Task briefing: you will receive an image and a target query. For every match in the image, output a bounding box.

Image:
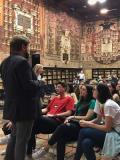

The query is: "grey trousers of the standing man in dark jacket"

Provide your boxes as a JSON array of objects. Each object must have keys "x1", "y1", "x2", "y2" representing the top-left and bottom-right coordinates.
[{"x1": 5, "y1": 120, "x2": 33, "y2": 160}]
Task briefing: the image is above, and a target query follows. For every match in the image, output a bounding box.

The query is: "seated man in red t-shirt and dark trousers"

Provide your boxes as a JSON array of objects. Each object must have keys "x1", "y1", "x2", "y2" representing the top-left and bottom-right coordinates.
[{"x1": 27, "y1": 82, "x2": 74, "y2": 158}]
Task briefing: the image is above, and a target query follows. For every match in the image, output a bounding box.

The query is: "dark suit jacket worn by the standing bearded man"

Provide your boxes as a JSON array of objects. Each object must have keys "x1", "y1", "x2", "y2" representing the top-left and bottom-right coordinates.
[{"x1": 0, "y1": 55, "x2": 41, "y2": 122}]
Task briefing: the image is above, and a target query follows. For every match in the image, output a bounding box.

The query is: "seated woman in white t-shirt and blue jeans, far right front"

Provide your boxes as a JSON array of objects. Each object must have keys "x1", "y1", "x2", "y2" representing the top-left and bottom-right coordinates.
[{"x1": 74, "y1": 84, "x2": 120, "y2": 160}]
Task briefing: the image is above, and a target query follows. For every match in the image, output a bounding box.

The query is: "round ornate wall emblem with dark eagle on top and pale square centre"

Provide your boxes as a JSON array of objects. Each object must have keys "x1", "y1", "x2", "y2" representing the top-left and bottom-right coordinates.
[{"x1": 92, "y1": 22, "x2": 120, "y2": 64}]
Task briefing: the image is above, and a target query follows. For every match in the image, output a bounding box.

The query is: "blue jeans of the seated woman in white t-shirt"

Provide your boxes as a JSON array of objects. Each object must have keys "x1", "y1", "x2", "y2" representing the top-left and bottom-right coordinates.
[{"x1": 74, "y1": 128, "x2": 106, "y2": 160}]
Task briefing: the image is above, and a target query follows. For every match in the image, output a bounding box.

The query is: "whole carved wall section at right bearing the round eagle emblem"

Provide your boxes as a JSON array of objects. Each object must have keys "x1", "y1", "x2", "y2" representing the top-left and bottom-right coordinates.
[{"x1": 81, "y1": 19, "x2": 120, "y2": 64}]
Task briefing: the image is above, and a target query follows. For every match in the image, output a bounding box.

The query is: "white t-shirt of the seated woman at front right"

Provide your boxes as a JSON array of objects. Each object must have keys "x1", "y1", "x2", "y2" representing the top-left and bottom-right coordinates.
[{"x1": 94, "y1": 99, "x2": 120, "y2": 127}]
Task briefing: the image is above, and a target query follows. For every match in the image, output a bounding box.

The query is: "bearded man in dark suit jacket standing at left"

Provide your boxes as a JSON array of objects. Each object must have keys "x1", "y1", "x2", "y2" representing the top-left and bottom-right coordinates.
[{"x1": 0, "y1": 36, "x2": 42, "y2": 160}]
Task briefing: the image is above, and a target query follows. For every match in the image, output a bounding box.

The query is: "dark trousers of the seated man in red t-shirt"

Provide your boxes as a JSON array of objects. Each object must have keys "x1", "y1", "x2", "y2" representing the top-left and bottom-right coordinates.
[{"x1": 27, "y1": 116, "x2": 61, "y2": 155}]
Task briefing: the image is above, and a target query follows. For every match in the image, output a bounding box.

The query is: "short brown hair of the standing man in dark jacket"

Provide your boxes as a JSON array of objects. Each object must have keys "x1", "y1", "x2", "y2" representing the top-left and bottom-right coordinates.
[{"x1": 10, "y1": 36, "x2": 29, "y2": 54}]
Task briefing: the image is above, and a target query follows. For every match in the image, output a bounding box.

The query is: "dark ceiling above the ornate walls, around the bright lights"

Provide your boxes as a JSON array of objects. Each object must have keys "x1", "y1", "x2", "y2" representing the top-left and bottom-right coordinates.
[{"x1": 45, "y1": 0, "x2": 120, "y2": 20}]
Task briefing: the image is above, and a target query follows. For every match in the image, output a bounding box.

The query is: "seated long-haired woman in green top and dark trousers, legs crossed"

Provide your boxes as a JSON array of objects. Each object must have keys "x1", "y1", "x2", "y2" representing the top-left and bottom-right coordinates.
[{"x1": 45, "y1": 85, "x2": 95, "y2": 160}]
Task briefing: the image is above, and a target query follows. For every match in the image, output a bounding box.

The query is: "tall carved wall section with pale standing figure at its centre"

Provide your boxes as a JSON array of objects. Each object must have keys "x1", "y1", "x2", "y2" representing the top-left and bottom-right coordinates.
[{"x1": 46, "y1": 8, "x2": 81, "y2": 61}]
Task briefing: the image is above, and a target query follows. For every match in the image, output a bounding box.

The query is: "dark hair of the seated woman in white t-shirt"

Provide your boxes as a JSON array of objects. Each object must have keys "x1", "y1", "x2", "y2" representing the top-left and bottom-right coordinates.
[{"x1": 97, "y1": 84, "x2": 112, "y2": 104}]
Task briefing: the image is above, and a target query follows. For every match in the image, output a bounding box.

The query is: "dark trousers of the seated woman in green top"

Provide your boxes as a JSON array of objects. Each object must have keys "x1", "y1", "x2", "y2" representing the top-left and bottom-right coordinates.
[{"x1": 48, "y1": 123, "x2": 80, "y2": 160}]
